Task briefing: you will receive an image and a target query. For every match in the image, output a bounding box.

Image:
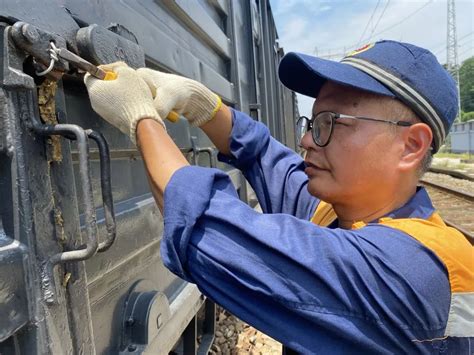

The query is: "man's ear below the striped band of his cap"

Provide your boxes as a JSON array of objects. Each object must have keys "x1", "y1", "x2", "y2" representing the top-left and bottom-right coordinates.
[{"x1": 399, "y1": 123, "x2": 433, "y2": 171}]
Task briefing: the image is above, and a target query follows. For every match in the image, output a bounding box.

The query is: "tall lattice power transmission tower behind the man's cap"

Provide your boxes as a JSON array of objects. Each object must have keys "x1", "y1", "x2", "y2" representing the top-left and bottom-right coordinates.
[{"x1": 446, "y1": 0, "x2": 461, "y2": 121}]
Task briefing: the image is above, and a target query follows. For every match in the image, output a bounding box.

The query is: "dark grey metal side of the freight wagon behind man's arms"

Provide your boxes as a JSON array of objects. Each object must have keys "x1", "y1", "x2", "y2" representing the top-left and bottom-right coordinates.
[{"x1": 0, "y1": 0, "x2": 297, "y2": 354}]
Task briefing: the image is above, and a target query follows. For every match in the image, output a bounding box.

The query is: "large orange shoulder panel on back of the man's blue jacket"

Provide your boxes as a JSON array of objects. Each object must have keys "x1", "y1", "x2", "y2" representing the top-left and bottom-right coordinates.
[{"x1": 379, "y1": 213, "x2": 474, "y2": 293}]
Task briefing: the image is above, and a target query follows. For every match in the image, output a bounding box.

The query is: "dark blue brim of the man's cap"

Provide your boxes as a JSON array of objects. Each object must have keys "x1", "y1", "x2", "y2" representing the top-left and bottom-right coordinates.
[{"x1": 278, "y1": 52, "x2": 395, "y2": 97}]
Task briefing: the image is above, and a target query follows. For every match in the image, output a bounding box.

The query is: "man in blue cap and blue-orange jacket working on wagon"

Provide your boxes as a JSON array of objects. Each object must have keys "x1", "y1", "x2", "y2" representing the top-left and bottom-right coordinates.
[{"x1": 85, "y1": 41, "x2": 474, "y2": 354}]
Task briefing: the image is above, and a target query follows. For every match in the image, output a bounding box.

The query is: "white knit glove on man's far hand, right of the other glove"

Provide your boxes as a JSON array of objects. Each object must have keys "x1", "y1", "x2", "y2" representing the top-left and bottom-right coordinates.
[{"x1": 137, "y1": 68, "x2": 222, "y2": 127}]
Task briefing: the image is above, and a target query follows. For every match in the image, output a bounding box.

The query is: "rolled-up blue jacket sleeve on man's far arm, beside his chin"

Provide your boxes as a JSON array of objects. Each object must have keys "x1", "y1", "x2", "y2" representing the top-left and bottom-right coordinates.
[{"x1": 219, "y1": 110, "x2": 319, "y2": 219}]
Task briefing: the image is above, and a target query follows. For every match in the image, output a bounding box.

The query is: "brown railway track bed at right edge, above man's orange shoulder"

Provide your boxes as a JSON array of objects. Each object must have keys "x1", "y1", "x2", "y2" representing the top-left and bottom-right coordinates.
[{"x1": 420, "y1": 179, "x2": 474, "y2": 244}]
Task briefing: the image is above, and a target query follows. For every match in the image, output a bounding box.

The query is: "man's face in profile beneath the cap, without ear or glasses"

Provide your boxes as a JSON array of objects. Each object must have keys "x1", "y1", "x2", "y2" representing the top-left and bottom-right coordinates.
[{"x1": 301, "y1": 82, "x2": 403, "y2": 204}]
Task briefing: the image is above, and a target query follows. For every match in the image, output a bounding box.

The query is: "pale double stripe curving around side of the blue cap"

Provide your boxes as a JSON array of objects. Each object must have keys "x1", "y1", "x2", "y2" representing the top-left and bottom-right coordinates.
[{"x1": 341, "y1": 57, "x2": 446, "y2": 150}]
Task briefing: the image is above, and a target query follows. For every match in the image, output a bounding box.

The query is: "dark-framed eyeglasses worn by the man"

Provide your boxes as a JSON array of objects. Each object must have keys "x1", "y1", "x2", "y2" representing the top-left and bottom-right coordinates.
[{"x1": 296, "y1": 111, "x2": 413, "y2": 147}]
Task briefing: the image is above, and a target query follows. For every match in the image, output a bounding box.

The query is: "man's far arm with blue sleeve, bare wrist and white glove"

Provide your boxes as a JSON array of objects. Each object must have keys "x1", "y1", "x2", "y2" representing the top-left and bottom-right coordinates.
[{"x1": 137, "y1": 68, "x2": 318, "y2": 219}]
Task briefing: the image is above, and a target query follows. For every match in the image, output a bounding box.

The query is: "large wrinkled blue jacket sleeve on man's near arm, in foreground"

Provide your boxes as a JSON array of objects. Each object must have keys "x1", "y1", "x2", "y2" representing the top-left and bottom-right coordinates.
[{"x1": 161, "y1": 166, "x2": 450, "y2": 353}]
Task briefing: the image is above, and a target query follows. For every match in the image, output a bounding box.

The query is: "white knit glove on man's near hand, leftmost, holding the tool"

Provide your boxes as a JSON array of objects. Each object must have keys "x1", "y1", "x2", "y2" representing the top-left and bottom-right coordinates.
[{"x1": 84, "y1": 62, "x2": 166, "y2": 144}]
